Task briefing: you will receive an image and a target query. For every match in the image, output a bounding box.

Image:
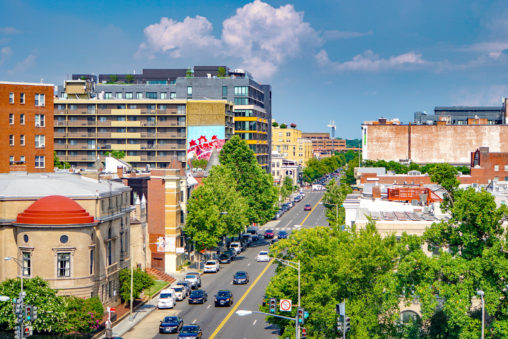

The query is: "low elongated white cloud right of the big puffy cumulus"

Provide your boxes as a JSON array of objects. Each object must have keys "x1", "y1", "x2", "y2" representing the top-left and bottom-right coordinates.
[{"x1": 315, "y1": 50, "x2": 427, "y2": 72}]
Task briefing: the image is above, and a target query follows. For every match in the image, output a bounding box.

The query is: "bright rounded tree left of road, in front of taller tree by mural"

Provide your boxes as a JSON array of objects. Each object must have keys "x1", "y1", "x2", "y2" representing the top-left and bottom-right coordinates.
[{"x1": 185, "y1": 165, "x2": 248, "y2": 249}]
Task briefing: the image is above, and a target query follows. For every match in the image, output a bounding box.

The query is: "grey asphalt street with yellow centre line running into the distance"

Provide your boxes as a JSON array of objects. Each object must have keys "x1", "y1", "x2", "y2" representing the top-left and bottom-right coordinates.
[{"x1": 123, "y1": 192, "x2": 328, "y2": 339}]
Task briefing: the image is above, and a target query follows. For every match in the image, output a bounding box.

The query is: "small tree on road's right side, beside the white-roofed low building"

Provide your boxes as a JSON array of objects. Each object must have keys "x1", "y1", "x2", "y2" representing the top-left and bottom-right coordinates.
[{"x1": 323, "y1": 179, "x2": 352, "y2": 226}]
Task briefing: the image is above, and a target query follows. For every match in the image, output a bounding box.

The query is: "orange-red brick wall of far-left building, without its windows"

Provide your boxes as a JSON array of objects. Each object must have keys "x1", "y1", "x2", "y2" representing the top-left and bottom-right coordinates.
[{"x1": 0, "y1": 83, "x2": 54, "y2": 173}]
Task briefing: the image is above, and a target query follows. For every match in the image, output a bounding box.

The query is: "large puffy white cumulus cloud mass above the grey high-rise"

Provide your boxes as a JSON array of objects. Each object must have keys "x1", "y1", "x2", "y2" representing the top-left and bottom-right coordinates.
[{"x1": 137, "y1": 0, "x2": 321, "y2": 78}]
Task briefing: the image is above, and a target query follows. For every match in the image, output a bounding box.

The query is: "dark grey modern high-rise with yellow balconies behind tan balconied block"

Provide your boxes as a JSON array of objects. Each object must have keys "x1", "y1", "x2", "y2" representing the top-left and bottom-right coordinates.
[{"x1": 67, "y1": 66, "x2": 272, "y2": 171}]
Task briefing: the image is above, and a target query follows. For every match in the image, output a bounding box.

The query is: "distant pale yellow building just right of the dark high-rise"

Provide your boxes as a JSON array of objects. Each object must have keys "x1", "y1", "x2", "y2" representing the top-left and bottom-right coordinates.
[{"x1": 272, "y1": 126, "x2": 313, "y2": 167}]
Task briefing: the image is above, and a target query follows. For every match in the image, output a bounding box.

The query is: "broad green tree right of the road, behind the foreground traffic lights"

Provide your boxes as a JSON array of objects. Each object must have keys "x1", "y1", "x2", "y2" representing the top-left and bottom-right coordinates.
[{"x1": 266, "y1": 223, "x2": 404, "y2": 338}]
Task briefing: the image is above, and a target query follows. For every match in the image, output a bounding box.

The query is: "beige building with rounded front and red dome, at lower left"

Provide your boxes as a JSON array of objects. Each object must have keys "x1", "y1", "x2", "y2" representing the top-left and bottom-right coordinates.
[{"x1": 0, "y1": 173, "x2": 134, "y2": 305}]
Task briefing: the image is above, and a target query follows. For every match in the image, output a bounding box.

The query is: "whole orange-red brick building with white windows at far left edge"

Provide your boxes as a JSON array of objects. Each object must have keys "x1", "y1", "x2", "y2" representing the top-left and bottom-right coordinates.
[{"x1": 0, "y1": 82, "x2": 54, "y2": 173}]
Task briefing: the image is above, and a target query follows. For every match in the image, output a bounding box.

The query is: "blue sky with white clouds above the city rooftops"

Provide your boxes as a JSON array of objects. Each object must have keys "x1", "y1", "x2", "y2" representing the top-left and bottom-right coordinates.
[{"x1": 0, "y1": 0, "x2": 508, "y2": 138}]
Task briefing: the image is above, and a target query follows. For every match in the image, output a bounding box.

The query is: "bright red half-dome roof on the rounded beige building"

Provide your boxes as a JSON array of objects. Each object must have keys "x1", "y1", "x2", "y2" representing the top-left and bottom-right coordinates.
[{"x1": 16, "y1": 195, "x2": 94, "y2": 225}]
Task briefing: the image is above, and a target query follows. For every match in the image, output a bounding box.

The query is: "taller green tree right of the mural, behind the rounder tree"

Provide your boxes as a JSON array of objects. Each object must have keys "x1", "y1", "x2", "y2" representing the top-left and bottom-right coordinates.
[{"x1": 219, "y1": 135, "x2": 278, "y2": 224}]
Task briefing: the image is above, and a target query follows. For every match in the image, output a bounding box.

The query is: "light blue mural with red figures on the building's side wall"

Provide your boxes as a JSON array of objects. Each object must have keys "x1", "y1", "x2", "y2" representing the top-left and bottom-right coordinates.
[{"x1": 187, "y1": 126, "x2": 226, "y2": 160}]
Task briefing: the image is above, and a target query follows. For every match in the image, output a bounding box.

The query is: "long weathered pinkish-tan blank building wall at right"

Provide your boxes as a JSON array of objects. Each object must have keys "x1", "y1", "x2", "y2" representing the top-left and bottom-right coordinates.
[{"x1": 362, "y1": 125, "x2": 508, "y2": 165}]
